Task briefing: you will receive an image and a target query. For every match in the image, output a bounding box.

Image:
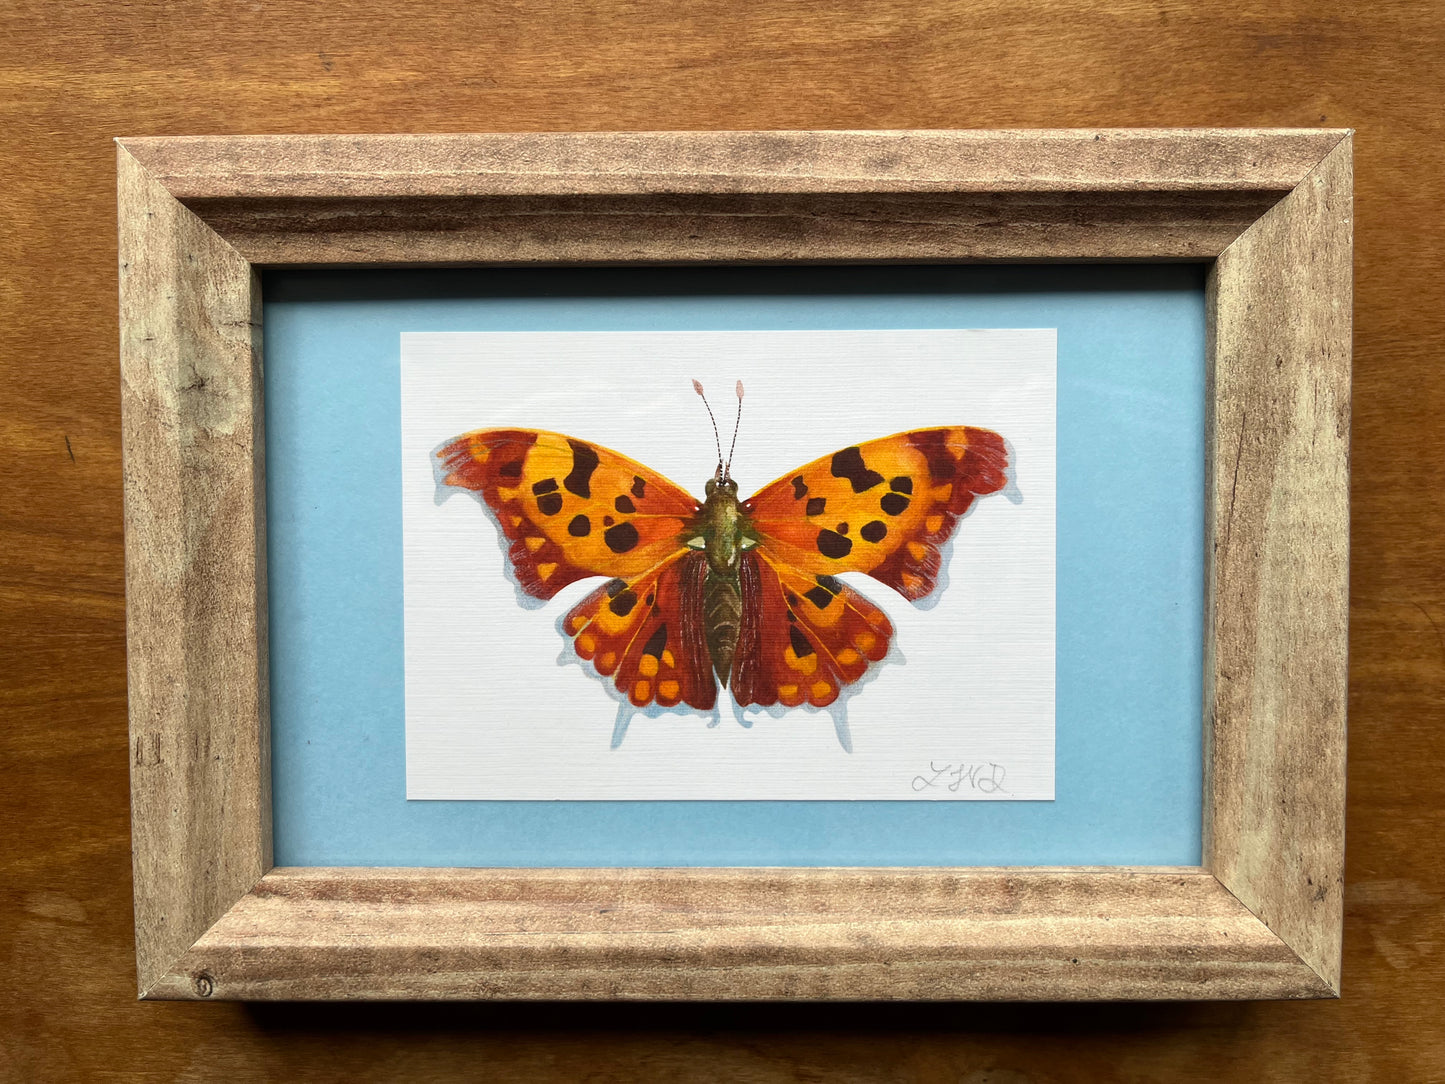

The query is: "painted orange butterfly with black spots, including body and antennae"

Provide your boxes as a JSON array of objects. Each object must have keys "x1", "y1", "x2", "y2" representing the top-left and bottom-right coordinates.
[{"x1": 435, "y1": 382, "x2": 1009, "y2": 725}]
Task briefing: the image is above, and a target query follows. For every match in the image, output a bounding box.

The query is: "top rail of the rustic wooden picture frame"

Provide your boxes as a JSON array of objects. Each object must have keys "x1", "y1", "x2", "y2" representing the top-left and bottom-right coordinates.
[{"x1": 120, "y1": 129, "x2": 1341, "y2": 267}]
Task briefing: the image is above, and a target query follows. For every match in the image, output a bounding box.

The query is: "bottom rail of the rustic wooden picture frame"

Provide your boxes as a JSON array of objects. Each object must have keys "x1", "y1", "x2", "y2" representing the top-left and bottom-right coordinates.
[{"x1": 147, "y1": 867, "x2": 1329, "y2": 1002}]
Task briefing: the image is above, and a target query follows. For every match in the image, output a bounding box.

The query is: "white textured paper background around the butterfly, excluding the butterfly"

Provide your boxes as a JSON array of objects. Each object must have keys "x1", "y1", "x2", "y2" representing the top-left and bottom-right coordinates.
[{"x1": 402, "y1": 330, "x2": 1055, "y2": 801}]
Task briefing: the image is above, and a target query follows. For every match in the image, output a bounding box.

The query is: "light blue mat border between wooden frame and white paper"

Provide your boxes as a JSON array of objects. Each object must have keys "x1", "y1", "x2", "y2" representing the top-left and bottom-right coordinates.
[{"x1": 264, "y1": 266, "x2": 1205, "y2": 866}]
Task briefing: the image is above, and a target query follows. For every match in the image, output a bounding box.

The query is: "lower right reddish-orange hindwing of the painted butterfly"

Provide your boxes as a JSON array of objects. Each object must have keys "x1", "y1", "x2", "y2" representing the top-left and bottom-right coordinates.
[{"x1": 728, "y1": 548, "x2": 893, "y2": 708}]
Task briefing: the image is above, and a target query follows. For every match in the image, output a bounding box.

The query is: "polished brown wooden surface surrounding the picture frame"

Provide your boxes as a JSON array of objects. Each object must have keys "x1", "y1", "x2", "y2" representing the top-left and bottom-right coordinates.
[{"x1": 0, "y1": 0, "x2": 1445, "y2": 1084}]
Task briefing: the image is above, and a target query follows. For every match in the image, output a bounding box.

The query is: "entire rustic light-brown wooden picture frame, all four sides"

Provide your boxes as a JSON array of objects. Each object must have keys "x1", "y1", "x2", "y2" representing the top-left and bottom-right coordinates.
[{"x1": 118, "y1": 130, "x2": 1351, "y2": 1000}]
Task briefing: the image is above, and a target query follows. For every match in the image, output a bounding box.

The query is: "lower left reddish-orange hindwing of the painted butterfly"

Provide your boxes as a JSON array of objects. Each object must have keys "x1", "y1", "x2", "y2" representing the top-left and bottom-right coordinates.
[{"x1": 562, "y1": 551, "x2": 717, "y2": 711}]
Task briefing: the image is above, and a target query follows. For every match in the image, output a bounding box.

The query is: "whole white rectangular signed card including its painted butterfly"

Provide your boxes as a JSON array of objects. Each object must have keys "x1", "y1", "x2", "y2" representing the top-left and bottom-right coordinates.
[{"x1": 402, "y1": 330, "x2": 1056, "y2": 801}]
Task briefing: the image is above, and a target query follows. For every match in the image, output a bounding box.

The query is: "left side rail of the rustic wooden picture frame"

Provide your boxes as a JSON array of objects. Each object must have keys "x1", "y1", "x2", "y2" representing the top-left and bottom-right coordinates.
[{"x1": 117, "y1": 150, "x2": 272, "y2": 986}]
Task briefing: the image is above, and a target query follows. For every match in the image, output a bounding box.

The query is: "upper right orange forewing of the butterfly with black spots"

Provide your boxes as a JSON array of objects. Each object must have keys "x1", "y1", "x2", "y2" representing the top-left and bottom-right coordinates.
[{"x1": 743, "y1": 426, "x2": 1009, "y2": 600}]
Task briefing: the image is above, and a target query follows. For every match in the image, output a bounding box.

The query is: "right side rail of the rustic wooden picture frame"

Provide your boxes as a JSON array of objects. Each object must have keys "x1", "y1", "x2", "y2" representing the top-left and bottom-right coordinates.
[{"x1": 1204, "y1": 139, "x2": 1353, "y2": 989}]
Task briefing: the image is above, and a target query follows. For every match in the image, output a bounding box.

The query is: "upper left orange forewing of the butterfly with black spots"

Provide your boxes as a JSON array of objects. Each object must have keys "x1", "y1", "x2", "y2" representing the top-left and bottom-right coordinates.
[{"x1": 435, "y1": 429, "x2": 699, "y2": 598}]
